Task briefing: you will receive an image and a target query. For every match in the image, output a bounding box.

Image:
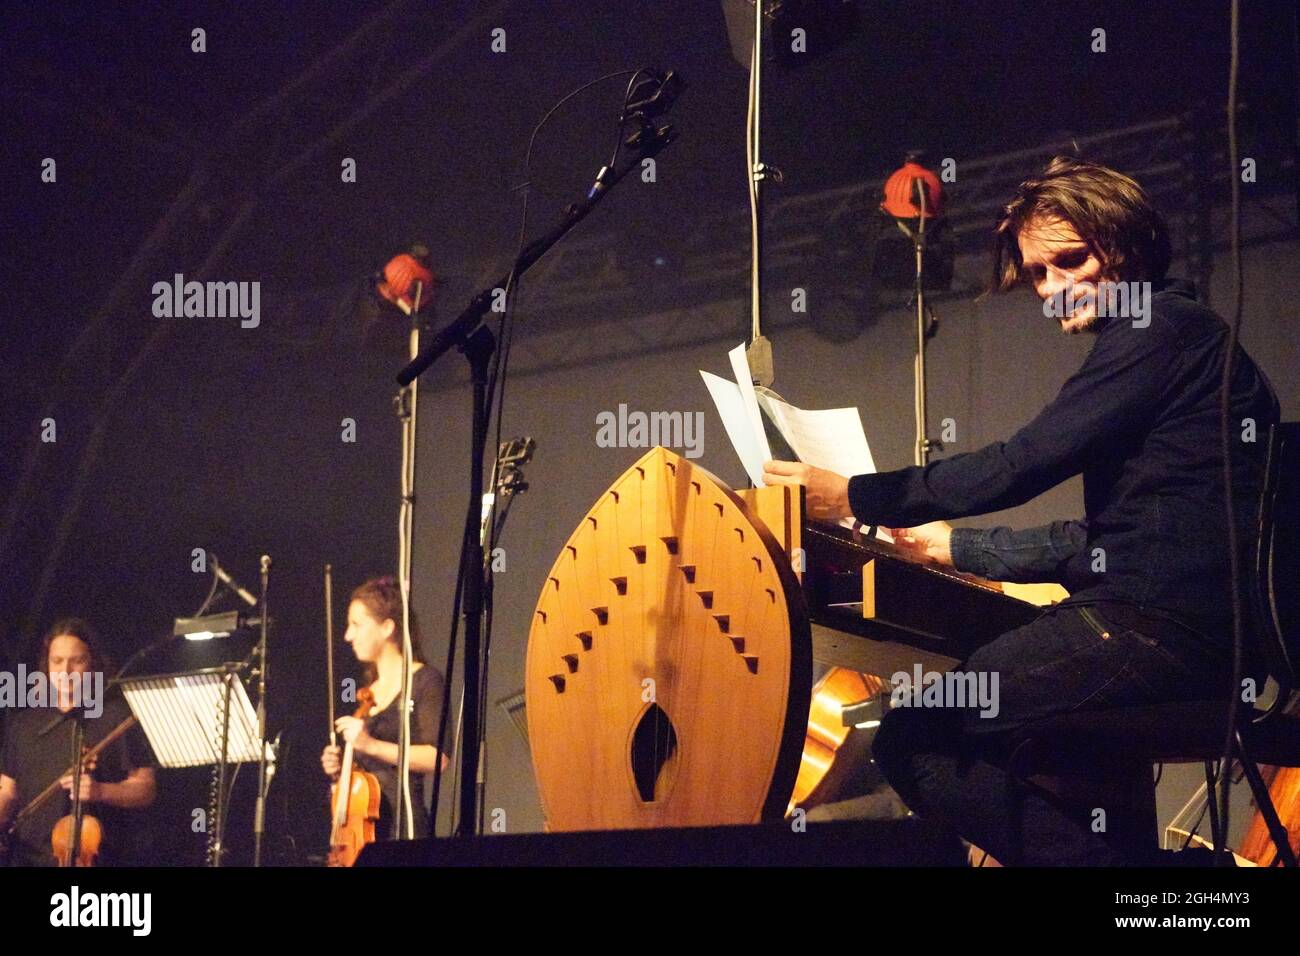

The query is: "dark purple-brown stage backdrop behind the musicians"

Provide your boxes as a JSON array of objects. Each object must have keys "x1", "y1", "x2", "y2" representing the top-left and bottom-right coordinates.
[{"x1": 0, "y1": 0, "x2": 1300, "y2": 864}]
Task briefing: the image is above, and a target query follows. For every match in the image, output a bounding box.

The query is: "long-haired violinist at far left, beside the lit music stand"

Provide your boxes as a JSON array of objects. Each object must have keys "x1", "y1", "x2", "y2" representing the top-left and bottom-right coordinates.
[{"x1": 0, "y1": 618, "x2": 157, "y2": 866}]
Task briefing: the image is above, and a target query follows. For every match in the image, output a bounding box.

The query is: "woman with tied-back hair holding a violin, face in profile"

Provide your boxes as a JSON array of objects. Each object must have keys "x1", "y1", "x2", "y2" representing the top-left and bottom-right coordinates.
[{"x1": 321, "y1": 578, "x2": 447, "y2": 839}]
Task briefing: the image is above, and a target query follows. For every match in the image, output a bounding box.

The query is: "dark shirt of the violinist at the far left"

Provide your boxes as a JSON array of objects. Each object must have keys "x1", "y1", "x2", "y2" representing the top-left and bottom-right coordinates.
[{"x1": 0, "y1": 697, "x2": 153, "y2": 866}]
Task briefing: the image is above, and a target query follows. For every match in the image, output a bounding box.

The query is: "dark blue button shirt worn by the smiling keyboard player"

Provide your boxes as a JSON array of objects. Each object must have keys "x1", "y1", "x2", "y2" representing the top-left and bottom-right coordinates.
[{"x1": 849, "y1": 280, "x2": 1279, "y2": 648}]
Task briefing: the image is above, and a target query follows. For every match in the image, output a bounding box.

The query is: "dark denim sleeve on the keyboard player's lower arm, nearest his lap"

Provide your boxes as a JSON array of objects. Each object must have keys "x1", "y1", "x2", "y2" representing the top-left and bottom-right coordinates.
[{"x1": 949, "y1": 522, "x2": 1088, "y2": 584}]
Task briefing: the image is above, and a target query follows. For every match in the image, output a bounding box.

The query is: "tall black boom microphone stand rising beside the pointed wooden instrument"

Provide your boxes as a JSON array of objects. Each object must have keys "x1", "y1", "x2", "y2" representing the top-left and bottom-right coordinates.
[{"x1": 397, "y1": 121, "x2": 676, "y2": 836}]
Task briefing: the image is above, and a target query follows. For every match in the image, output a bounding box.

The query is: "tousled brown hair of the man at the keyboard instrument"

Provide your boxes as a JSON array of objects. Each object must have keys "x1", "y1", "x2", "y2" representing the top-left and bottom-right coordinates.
[{"x1": 992, "y1": 156, "x2": 1170, "y2": 293}]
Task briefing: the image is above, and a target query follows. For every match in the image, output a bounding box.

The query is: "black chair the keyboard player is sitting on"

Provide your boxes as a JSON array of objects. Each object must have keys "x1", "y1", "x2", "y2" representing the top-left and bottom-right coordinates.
[{"x1": 1010, "y1": 421, "x2": 1300, "y2": 866}]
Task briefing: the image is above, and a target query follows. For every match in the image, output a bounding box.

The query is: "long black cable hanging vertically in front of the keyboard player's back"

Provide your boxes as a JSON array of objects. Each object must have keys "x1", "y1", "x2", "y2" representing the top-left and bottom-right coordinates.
[{"x1": 1212, "y1": 0, "x2": 1245, "y2": 865}]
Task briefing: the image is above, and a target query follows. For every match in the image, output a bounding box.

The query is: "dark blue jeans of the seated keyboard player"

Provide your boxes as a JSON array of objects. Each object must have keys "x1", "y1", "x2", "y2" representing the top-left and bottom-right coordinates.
[{"x1": 872, "y1": 606, "x2": 1231, "y2": 866}]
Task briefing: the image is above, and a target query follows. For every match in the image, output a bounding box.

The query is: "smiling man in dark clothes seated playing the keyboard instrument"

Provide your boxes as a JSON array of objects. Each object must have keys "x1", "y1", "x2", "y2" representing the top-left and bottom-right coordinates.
[{"x1": 766, "y1": 157, "x2": 1278, "y2": 865}]
